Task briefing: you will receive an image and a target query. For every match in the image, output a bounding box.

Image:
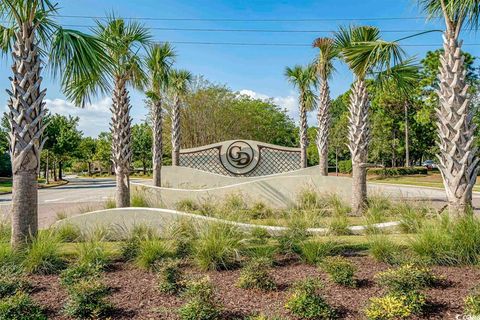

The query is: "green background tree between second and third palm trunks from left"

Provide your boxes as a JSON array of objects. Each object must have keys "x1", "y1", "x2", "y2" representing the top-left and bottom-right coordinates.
[{"x1": 132, "y1": 123, "x2": 153, "y2": 175}]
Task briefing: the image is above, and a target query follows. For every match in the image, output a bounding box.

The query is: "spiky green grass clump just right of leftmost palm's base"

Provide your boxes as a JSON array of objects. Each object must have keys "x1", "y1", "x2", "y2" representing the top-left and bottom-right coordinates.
[{"x1": 23, "y1": 231, "x2": 66, "y2": 274}]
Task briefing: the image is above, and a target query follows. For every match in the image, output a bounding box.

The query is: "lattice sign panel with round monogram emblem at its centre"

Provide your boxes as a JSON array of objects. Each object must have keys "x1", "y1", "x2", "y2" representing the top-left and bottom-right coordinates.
[{"x1": 179, "y1": 140, "x2": 301, "y2": 177}]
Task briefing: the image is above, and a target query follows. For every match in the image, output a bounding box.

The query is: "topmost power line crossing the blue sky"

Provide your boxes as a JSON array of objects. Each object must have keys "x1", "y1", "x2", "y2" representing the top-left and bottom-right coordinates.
[{"x1": 57, "y1": 15, "x2": 426, "y2": 22}]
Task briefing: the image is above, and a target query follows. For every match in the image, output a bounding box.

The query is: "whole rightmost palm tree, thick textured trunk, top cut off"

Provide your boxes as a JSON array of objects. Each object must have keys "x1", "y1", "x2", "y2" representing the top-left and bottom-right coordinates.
[{"x1": 420, "y1": 0, "x2": 480, "y2": 215}]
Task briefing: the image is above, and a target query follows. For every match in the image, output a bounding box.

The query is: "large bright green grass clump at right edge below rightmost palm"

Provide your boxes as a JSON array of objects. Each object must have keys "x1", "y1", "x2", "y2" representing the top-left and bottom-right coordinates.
[{"x1": 411, "y1": 214, "x2": 480, "y2": 265}]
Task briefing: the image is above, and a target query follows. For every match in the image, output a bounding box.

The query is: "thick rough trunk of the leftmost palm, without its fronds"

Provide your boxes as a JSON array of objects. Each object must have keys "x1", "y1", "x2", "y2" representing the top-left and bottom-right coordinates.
[{"x1": 7, "y1": 24, "x2": 46, "y2": 248}]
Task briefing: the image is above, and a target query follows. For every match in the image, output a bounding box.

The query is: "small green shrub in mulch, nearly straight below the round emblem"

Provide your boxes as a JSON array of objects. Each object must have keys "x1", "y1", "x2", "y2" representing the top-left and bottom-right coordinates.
[{"x1": 237, "y1": 259, "x2": 277, "y2": 291}]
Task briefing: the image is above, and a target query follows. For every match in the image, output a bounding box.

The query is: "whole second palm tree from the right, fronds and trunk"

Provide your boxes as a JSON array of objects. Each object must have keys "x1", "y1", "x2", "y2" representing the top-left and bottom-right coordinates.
[{"x1": 335, "y1": 26, "x2": 412, "y2": 215}]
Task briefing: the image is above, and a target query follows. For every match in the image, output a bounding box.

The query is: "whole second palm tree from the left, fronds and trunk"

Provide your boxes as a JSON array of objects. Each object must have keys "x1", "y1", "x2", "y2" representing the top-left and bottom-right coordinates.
[{"x1": 96, "y1": 17, "x2": 151, "y2": 208}]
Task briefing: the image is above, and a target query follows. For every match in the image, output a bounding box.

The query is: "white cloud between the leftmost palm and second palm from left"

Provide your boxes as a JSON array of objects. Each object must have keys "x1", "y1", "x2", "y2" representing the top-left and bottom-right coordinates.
[{"x1": 45, "y1": 98, "x2": 112, "y2": 137}]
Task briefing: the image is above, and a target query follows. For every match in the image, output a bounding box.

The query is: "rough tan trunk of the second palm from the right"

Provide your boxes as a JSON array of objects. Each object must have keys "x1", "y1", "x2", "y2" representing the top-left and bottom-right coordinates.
[{"x1": 348, "y1": 79, "x2": 369, "y2": 215}]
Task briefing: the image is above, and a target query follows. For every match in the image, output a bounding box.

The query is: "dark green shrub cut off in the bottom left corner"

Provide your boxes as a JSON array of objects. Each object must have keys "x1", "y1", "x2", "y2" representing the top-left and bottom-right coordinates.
[{"x1": 0, "y1": 292, "x2": 47, "y2": 320}]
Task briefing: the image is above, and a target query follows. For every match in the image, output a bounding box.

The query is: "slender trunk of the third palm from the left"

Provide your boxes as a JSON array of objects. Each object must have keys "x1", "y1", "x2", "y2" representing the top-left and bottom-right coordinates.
[{"x1": 153, "y1": 101, "x2": 163, "y2": 187}]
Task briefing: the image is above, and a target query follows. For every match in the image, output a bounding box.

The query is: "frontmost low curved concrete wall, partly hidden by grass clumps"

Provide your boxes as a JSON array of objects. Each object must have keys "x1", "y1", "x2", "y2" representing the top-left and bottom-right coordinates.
[{"x1": 54, "y1": 208, "x2": 399, "y2": 235}]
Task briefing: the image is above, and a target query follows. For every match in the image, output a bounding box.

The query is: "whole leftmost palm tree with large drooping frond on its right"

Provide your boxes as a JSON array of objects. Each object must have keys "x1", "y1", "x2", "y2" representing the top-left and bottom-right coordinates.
[{"x1": 0, "y1": 0, "x2": 110, "y2": 248}]
